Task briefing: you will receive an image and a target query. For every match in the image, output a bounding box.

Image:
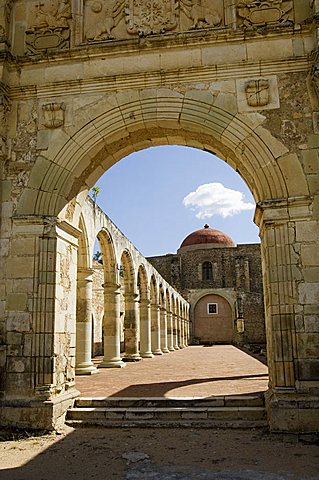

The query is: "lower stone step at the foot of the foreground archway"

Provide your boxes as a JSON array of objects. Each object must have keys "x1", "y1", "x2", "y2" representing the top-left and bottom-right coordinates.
[{"x1": 66, "y1": 406, "x2": 267, "y2": 428}]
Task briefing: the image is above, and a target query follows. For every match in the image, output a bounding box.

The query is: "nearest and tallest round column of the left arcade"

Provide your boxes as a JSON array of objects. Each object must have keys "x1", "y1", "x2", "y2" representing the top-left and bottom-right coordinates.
[{"x1": 75, "y1": 268, "x2": 97, "y2": 375}]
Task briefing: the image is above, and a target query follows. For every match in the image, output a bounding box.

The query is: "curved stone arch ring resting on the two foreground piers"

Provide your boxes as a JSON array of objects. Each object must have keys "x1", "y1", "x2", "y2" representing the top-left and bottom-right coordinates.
[{"x1": 18, "y1": 90, "x2": 308, "y2": 214}]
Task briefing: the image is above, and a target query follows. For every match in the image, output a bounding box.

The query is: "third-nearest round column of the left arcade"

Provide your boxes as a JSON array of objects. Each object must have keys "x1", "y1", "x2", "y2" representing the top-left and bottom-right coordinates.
[{"x1": 123, "y1": 293, "x2": 142, "y2": 362}]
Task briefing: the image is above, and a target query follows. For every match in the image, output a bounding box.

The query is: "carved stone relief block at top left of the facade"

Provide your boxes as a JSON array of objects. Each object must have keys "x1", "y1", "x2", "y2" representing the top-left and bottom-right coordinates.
[{"x1": 26, "y1": 0, "x2": 72, "y2": 53}]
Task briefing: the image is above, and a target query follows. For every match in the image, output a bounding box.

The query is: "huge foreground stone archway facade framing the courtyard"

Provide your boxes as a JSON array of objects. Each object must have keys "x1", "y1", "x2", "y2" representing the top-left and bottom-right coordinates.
[{"x1": 1, "y1": 6, "x2": 319, "y2": 431}]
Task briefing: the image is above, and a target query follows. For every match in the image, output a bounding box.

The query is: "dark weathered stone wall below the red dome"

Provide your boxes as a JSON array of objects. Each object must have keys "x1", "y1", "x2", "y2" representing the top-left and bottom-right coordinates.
[{"x1": 148, "y1": 244, "x2": 266, "y2": 343}]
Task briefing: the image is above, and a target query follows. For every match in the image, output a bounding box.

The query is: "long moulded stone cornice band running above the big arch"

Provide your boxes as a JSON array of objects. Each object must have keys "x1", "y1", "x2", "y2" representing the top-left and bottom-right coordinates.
[{"x1": 8, "y1": 56, "x2": 313, "y2": 100}]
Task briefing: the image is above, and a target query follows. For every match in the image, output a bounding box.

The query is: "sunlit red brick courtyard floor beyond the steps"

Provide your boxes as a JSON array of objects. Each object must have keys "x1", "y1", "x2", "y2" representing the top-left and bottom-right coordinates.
[{"x1": 76, "y1": 345, "x2": 268, "y2": 397}]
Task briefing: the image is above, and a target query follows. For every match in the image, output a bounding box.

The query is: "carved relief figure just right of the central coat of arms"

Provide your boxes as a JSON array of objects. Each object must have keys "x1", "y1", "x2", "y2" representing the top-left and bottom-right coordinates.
[{"x1": 181, "y1": 0, "x2": 222, "y2": 29}]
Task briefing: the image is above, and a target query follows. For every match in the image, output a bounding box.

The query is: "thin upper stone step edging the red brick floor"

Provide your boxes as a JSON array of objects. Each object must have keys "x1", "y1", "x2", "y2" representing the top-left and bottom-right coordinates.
[{"x1": 75, "y1": 394, "x2": 265, "y2": 408}]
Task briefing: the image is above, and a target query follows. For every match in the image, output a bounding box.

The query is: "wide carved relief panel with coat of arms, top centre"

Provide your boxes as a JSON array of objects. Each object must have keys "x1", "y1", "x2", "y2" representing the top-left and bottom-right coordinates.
[{"x1": 84, "y1": 0, "x2": 225, "y2": 42}]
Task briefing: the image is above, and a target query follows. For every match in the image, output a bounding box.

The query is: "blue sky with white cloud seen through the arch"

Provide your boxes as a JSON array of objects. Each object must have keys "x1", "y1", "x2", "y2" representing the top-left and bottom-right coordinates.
[{"x1": 92, "y1": 146, "x2": 259, "y2": 256}]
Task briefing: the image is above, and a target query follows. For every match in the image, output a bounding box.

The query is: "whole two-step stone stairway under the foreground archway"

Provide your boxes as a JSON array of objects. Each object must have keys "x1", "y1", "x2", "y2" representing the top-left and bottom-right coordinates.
[{"x1": 66, "y1": 394, "x2": 267, "y2": 428}]
